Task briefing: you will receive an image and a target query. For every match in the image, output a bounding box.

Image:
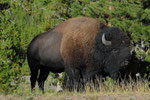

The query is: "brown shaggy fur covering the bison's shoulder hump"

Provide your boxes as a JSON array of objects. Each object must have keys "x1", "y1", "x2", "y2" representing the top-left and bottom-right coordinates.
[{"x1": 53, "y1": 17, "x2": 106, "y2": 70}]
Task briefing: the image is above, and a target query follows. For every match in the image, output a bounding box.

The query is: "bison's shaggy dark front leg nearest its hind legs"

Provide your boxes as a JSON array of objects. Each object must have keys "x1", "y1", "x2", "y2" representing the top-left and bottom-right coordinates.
[{"x1": 63, "y1": 68, "x2": 81, "y2": 91}]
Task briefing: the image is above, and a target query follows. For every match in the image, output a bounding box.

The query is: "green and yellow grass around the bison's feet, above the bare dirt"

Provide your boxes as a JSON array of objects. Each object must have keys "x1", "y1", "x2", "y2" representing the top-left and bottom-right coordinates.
[{"x1": 0, "y1": 77, "x2": 150, "y2": 100}]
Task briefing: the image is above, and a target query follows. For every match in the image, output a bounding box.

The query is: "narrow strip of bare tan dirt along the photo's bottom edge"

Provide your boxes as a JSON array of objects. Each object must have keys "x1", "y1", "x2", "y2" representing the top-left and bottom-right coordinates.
[{"x1": 0, "y1": 93, "x2": 150, "y2": 100}]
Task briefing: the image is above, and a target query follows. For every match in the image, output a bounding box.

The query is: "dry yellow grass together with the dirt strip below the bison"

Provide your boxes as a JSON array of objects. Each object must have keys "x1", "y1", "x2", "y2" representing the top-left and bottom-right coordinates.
[{"x1": 0, "y1": 75, "x2": 150, "y2": 100}]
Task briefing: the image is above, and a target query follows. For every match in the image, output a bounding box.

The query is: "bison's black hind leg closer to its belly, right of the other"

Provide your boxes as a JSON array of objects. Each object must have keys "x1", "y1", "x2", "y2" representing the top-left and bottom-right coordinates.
[{"x1": 38, "y1": 66, "x2": 49, "y2": 93}]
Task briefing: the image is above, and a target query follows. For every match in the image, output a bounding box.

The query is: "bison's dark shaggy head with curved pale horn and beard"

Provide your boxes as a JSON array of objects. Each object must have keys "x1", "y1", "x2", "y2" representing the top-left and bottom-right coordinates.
[{"x1": 95, "y1": 27, "x2": 130, "y2": 79}]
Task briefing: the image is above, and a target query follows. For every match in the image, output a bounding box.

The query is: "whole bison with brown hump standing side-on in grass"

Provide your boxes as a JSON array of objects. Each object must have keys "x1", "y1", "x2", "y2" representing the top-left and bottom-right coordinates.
[{"x1": 27, "y1": 17, "x2": 130, "y2": 92}]
